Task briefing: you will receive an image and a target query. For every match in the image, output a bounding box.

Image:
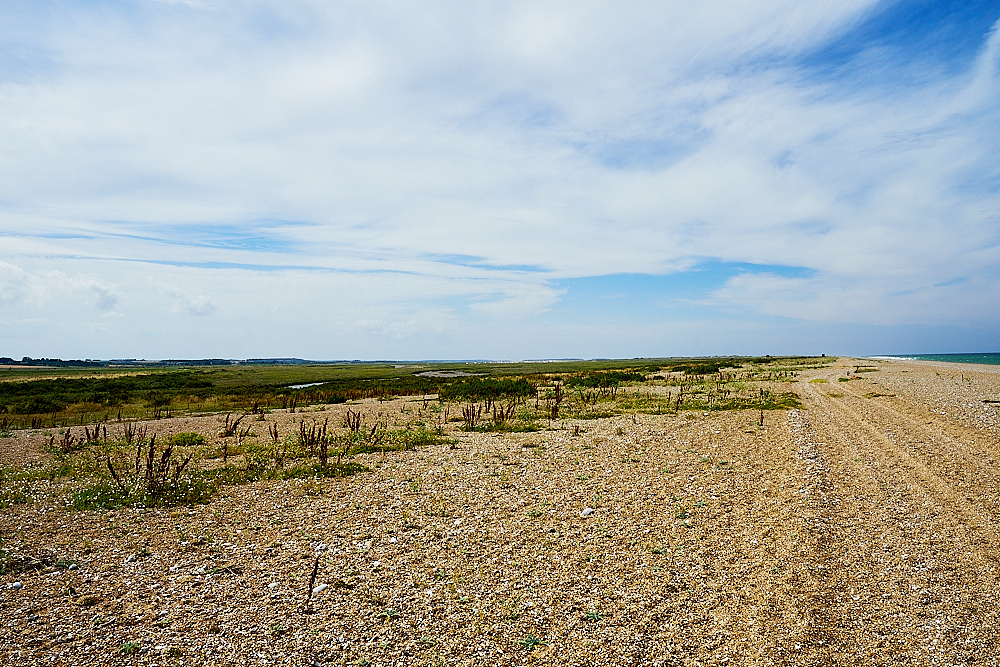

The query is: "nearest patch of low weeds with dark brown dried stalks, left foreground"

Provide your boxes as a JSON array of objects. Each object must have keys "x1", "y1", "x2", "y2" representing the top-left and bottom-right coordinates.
[{"x1": 0, "y1": 412, "x2": 450, "y2": 510}]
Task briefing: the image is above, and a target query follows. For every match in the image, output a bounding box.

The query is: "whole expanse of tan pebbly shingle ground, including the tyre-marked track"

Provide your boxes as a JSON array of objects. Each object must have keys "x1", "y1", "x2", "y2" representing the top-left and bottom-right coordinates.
[{"x1": 0, "y1": 360, "x2": 1000, "y2": 666}]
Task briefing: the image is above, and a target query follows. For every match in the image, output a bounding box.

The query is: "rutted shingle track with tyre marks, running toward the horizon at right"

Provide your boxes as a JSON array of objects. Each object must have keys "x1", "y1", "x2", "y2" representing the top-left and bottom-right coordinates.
[{"x1": 788, "y1": 368, "x2": 1000, "y2": 665}]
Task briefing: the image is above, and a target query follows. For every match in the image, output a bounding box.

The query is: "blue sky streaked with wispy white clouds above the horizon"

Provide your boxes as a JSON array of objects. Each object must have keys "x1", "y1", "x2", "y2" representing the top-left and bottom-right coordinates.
[{"x1": 0, "y1": 0, "x2": 1000, "y2": 359}]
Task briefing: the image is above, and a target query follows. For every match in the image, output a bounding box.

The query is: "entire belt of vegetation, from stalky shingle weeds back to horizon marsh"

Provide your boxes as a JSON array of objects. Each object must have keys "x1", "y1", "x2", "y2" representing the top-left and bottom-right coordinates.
[{"x1": 0, "y1": 357, "x2": 825, "y2": 510}]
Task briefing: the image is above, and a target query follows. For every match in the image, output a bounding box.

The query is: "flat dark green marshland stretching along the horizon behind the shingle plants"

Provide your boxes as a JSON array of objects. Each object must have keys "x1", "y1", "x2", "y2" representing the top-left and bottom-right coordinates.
[{"x1": 0, "y1": 357, "x2": 816, "y2": 434}]
